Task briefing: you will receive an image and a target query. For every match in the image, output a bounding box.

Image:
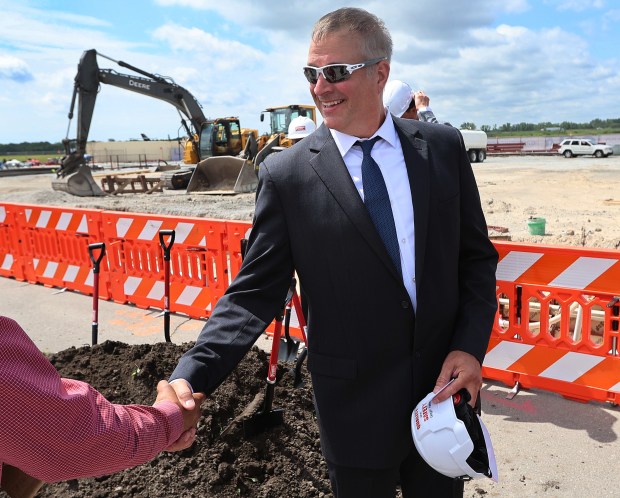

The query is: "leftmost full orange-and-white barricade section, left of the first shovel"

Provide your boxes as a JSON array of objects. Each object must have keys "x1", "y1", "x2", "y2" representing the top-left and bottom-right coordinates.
[{"x1": 9, "y1": 204, "x2": 109, "y2": 299}]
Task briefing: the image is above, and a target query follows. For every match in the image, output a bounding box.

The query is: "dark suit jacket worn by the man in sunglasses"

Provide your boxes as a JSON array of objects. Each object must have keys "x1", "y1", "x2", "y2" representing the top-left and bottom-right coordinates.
[{"x1": 172, "y1": 118, "x2": 497, "y2": 468}]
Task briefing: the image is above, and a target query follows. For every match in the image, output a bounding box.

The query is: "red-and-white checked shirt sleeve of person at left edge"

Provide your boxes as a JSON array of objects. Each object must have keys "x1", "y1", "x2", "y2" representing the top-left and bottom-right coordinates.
[{"x1": 0, "y1": 316, "x2": 183, "y2": 482}]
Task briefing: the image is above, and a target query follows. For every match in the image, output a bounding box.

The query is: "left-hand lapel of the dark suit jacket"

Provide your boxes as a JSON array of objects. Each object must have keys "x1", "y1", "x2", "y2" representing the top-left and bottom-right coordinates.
[{"x1": 306, "y1": 125, "x2": 402, "y2": 281}]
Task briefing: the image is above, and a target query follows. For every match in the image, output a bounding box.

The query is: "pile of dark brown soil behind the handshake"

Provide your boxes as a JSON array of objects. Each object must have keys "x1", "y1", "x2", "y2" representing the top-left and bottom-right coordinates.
[{"x1": 38, "y1": 341, "x2": 331, "y2": 498}]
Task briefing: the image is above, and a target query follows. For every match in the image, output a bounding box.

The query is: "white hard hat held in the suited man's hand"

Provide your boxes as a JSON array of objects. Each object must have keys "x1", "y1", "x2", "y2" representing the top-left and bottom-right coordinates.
[{"x1": 411, "y1": 389, "x2": 498, "y2": 482}]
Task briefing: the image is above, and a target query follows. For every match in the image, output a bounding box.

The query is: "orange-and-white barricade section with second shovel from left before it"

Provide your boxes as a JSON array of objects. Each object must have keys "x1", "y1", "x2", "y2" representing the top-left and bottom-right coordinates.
[{"x1": 102, "y1": 211, "x2": 228, "y2": 318}]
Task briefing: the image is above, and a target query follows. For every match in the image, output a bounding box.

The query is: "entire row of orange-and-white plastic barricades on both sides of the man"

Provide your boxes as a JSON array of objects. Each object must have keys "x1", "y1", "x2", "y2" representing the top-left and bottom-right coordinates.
[{"x1": 0, "y1": 203, "x2": 620, "y2": 404}]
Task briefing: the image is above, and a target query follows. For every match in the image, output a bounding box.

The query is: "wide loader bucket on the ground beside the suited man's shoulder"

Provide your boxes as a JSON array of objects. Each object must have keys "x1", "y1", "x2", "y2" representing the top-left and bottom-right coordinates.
[{"x1": 187, "y1": 156, "x2": 258, "y2": 194}]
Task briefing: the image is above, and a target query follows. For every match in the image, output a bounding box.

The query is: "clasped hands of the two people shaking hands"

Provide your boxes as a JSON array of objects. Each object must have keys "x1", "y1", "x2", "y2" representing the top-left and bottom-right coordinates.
[{"x1": 153, "y1": 379, "x2": 205, "y2": 451}]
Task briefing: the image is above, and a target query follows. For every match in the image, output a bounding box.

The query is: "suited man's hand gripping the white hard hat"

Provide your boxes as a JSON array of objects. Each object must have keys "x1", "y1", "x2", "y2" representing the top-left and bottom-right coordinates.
[{"x1": 433, "y1": 351, "x2": 482, "y2": 407}]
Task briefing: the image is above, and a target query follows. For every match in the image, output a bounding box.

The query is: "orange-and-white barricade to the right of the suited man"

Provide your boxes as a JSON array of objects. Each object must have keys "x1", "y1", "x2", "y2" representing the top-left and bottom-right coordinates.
[{"x1": 483, "y1": 242, "x2": 620, "y2": 404}]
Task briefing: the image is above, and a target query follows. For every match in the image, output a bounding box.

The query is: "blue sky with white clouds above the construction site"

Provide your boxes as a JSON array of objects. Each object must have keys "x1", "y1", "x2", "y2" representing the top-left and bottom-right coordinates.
[{"x1": 0, "y1": 0, "x2": 620, "y2": 143}]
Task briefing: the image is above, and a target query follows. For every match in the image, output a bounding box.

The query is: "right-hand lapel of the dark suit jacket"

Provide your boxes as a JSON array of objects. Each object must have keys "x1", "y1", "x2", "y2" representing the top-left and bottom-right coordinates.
[{"x1": 394, "y1": 118, "x2": 430, "y2": 288}]
